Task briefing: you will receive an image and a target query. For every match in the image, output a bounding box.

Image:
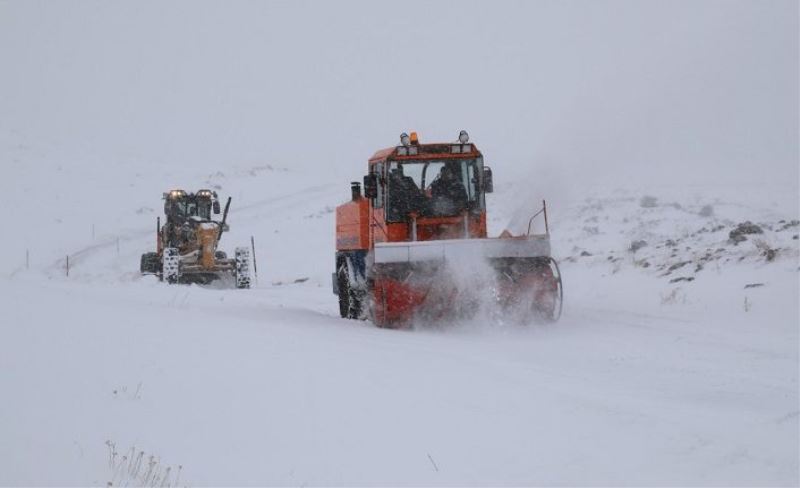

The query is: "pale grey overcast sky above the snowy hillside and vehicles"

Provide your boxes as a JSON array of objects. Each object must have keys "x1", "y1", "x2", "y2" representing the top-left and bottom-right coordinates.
[{"x1": 0, "y1": 0, "x2": 798, "y2": 185}]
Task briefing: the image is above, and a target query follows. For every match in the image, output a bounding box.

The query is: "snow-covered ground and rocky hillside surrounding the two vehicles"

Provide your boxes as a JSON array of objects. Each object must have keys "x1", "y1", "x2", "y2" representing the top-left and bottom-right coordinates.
[{"x1": 0, "y1": 148, "x2": 800, "y2": 486}]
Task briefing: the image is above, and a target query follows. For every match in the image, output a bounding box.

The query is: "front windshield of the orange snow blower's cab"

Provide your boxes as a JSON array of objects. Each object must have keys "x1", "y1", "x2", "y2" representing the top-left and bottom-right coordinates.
[{"x1": 386, "y1": 158, "x2": 484, "y2": 222}]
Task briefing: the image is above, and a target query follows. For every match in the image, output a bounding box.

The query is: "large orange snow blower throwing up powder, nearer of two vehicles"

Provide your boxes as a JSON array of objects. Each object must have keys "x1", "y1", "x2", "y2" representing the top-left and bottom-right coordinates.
[{"x1": 333, "y1": 131, "x2": 563, "y2": 327}]
